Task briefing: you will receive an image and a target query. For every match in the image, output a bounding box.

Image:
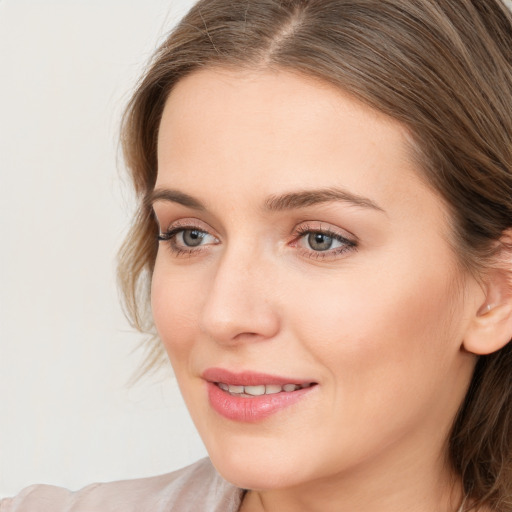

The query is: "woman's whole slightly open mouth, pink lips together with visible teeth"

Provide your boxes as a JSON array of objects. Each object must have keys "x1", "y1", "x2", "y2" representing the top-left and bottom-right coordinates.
[{"x1": 202, "y1": 368, "x2": 316, "y2": 423}]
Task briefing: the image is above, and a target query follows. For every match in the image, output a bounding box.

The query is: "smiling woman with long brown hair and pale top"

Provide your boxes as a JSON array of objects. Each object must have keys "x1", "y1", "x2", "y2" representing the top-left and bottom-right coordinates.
[{"x1": 4, "y1": 0, "x2": 512, "y2": 512}]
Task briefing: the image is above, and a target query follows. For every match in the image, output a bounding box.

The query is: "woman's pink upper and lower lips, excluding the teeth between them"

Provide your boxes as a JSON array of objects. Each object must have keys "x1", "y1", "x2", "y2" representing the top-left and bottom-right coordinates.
[{"x1": 202, "y1": 368, "x2": 317, "y2": 423}]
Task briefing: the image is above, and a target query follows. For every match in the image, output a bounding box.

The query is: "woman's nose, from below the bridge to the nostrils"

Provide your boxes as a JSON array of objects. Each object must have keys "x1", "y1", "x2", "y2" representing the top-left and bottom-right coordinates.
[{"x1": 200, "y1": 243, "x2": 280, "y2": 344}]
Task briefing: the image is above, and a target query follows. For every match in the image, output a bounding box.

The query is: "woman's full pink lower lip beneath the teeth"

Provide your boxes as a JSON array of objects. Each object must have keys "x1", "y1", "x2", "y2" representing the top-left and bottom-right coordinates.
[{"x1": 206, "y1": 382, "x2": 316, "y2": 423}]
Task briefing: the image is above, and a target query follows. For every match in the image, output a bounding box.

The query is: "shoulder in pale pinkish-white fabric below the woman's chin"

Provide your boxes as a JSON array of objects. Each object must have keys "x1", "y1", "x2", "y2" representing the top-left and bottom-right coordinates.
[{"x1": 0, "y1": 459, "x2": 242, "y2": 512}]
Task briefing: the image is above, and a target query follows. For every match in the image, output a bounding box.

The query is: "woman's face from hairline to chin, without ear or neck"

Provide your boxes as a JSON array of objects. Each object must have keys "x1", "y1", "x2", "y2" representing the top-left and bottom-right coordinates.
[{"x1": 152, "y1": 70, "x2": 483, "y2": 489}]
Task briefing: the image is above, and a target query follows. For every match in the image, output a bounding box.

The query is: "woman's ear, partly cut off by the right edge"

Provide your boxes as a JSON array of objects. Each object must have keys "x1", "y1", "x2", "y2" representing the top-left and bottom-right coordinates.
[{"x1": 463, "y1": 230, "x2": 512, "y2": 355}]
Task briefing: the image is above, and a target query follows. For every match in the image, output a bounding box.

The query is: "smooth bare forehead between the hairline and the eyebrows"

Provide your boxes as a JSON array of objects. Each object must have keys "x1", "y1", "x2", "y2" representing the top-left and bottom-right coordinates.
[{"x1": 157, "y1": 69, "x2": 448, "y2": 226}]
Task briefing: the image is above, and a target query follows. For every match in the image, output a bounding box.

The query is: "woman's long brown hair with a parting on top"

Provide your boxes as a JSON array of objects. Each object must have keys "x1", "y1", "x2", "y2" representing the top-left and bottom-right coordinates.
[{"x1": 119, "y1": 0, "x2": 512, "y2": 512}]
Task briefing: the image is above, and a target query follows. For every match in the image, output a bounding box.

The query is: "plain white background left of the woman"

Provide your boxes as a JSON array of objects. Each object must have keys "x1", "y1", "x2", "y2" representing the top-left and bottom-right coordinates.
[{"x1": 0, "y1": 0, "x2": 205, "y2": 496}]
